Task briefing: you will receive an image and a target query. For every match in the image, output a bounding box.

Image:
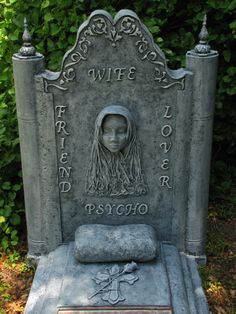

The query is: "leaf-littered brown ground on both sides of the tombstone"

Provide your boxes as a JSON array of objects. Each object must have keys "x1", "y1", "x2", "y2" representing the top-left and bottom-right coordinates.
[{"x1": 0, "y1": 203, "x2": 236, "y2": 314}]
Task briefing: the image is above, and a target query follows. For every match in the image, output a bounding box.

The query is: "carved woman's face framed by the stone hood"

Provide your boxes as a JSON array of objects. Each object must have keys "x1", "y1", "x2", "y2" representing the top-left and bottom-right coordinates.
[{"x1": 102, "y1": 114, "x2": 127, "y2": 153}]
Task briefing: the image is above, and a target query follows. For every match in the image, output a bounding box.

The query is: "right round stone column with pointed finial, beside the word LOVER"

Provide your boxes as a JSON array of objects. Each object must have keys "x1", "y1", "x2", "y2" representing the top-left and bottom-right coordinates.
[{"x1": 186, "y1": 17, "x2": 218, "y2": 257}]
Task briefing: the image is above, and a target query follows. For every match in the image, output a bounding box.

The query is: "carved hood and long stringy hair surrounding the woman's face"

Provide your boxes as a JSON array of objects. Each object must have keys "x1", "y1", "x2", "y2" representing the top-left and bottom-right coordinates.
[{"x1": 86, "y1": 105, "x2": 147, "y2": 196}]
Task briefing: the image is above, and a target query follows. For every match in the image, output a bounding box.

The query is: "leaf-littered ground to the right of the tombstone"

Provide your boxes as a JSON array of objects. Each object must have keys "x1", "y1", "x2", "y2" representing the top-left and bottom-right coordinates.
[{"x1": 200, "y1": 204, "x2": 236, "y2": 314}]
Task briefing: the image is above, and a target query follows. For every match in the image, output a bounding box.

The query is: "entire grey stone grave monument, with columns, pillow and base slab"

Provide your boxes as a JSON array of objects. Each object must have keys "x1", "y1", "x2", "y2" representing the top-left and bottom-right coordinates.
[{"x1": 13, "y1": 10, "x2": 218, "y2": 314}]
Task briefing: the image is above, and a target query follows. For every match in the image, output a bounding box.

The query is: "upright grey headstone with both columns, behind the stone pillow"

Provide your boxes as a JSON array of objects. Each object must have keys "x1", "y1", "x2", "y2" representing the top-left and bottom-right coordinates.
[{"x1": 13, "y1": 10, "x2": 217, "y2": 256}]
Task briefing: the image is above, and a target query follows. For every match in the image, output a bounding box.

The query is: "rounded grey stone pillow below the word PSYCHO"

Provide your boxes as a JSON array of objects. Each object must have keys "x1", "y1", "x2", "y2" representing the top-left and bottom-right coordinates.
[{"x1": 75, "y1": 224, "x2": 157, "y2": 263}]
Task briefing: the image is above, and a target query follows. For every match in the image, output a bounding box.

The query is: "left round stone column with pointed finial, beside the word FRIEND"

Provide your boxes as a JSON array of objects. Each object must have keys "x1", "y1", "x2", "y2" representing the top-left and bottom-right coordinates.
[{"x1": 13, "y1": 20, "x2": 45, "y2": 259}]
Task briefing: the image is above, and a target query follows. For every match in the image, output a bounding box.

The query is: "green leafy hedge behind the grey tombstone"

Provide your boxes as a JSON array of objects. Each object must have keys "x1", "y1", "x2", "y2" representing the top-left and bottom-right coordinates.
[{"x1": 0, "y1": 0, "x2": 236, "y2": 249}]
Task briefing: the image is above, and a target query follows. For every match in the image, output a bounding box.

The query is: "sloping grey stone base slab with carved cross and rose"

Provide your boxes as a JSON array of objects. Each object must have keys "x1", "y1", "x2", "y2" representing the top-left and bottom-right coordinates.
[{"x1": 25, "y1": 242, "x2": 209, "y2": 314}]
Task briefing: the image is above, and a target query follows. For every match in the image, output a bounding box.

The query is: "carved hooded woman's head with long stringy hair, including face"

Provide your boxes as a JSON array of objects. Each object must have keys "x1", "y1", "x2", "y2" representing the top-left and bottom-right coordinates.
[{"x1": 86, "y1": 105, "x2": 147, "y2": 196}]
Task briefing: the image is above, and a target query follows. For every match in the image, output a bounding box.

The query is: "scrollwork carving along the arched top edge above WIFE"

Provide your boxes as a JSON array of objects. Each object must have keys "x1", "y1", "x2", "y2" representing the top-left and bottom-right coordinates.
[{"x1": 45, "y1": 10, "x2": 185, "y2": 92}]
